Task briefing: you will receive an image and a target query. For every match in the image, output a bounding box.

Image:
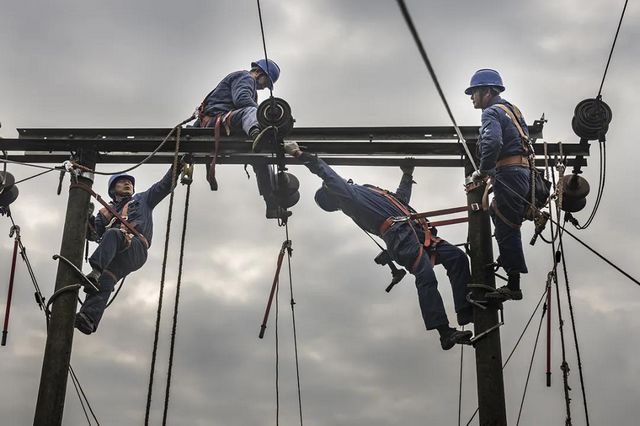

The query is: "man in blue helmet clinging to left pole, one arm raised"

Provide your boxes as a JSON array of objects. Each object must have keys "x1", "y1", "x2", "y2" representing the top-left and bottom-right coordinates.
[{"x1": 75, "y1": 165, "x2": 183, "y2": 334}]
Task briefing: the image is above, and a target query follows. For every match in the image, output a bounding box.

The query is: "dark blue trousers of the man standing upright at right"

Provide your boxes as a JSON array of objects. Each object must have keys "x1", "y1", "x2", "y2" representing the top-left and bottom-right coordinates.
[{"x1": 491, "y1": 166, "x2": 530, "y2": 274}]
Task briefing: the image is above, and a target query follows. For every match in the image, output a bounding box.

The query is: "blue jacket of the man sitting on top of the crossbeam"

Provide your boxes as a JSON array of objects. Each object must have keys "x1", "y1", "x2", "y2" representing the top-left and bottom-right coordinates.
[{"x1": 204, "y1": 71, "x2": 258, "y2": 117}]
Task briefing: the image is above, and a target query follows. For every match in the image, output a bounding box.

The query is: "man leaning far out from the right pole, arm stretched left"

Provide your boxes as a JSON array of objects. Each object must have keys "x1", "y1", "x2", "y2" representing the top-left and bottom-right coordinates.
[{"x1": 284, "y1": 142, "x2": 473, "y2": 350}]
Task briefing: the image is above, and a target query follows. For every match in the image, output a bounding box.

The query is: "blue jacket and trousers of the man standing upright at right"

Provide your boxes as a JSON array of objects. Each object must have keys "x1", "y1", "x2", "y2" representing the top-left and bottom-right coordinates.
[{"x1": 477, "y1": 96, "x2": 530, "y2": 274}]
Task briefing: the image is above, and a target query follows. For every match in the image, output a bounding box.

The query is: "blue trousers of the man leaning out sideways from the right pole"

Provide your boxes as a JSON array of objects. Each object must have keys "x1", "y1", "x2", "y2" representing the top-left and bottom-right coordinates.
[{"x1": 382, "y1": 223, "x2": 471, "y2": 330}]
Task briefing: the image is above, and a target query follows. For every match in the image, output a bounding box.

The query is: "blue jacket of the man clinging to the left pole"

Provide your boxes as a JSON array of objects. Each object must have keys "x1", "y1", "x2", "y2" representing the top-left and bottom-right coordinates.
[{"x1": 94, "y1": 169, "x2": 179, "y2": 246}]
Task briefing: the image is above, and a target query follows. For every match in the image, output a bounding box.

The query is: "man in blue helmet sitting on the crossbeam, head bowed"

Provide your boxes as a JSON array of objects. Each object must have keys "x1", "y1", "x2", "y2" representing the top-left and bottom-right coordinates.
[{"x1": 193, "y1": 59, "x2": 291, "y2": 219}]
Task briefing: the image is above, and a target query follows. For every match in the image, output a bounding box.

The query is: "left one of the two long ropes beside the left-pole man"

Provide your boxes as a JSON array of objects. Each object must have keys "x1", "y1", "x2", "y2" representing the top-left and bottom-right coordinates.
[{"x1": 144, "y1": 127, "x2": 180, "y2": 426}]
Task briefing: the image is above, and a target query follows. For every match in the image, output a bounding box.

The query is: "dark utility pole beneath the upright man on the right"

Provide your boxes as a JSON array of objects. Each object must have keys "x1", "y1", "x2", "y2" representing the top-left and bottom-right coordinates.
[{"x1": 466, "y1": 167, "x2": 507, "y2": 426}]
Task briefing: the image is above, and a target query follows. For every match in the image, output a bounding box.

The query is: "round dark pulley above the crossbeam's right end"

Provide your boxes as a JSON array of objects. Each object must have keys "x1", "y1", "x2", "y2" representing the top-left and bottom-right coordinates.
[{"x1": 571, "y1": 98, "x2": 612, "y2": 142}]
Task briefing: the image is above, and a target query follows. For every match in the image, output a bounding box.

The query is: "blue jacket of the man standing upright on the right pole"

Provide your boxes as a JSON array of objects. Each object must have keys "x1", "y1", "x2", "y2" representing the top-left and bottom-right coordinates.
[{"x1": 477, "y1": 96, "x2": 529, "y2": 175}]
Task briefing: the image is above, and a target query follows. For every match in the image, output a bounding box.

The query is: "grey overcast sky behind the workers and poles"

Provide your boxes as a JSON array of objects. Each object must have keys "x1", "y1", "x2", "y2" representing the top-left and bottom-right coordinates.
[{"x1": 0, "y1": 0, "x2": 640, "y2": 426}]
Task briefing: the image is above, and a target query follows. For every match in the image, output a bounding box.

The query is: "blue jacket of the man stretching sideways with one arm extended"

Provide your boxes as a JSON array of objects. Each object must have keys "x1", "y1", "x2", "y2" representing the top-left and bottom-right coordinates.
[{"x1": 299, "y1": 153, "x2": 413, "y2": 236}]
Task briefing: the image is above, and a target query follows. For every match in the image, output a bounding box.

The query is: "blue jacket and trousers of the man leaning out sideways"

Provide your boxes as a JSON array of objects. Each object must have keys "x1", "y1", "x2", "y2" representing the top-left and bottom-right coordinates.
[{"x1": 299, "y1": 153, "x2": 470, "y2": 330}]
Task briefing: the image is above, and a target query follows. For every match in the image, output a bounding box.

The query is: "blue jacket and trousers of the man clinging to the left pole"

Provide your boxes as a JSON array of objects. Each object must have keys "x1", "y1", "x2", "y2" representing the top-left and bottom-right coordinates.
[{"x1": 80, "y1": 169, "x2": 180, "y2": 331}]
